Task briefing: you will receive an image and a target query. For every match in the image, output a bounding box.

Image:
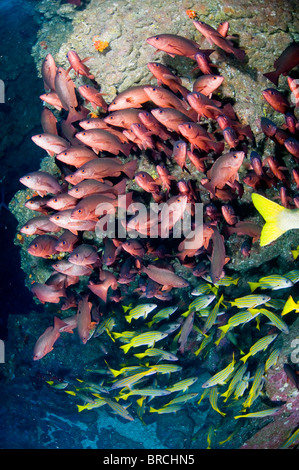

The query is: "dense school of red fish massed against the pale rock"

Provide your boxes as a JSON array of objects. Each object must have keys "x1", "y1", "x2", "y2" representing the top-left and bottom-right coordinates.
[{"x1": 14, "y1": 14, "x2": 299, "y2": 438}]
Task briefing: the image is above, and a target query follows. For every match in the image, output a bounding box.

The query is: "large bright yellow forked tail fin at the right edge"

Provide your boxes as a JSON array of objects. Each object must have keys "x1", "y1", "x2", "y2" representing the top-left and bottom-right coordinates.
[{"x1": 251, "y1": 193, "x2": 286, "y2": 246}]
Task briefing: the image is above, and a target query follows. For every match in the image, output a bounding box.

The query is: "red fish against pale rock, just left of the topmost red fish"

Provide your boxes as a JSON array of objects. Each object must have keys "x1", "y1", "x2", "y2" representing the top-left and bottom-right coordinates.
[{"x1": 146, "y1": 34, "x2": 206, "y2": 59}]
